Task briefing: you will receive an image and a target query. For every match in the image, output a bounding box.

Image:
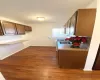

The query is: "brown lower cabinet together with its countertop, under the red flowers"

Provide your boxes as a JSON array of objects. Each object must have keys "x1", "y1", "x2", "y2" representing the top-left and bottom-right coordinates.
[{"x1": 56, "y1": 41, "x2": 89, "y2": 69}]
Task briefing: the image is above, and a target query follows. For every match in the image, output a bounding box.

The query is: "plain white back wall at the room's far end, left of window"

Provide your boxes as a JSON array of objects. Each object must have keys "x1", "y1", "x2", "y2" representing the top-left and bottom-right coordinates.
[{"x1": 25, "y1": 23, "x2": 60, "y2": 46}]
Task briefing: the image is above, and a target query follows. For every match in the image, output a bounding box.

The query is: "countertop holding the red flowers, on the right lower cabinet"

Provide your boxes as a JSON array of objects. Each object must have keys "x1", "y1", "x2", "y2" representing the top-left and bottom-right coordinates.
[{"x1": 56, "y1": 41, "x2": 89, "y2": 51}]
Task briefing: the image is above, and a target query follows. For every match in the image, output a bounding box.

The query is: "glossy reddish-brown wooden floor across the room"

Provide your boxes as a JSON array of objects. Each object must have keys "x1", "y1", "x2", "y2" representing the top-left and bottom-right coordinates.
[{"x1": 0, "y1": 47, "x2": 100, "y2": 80}]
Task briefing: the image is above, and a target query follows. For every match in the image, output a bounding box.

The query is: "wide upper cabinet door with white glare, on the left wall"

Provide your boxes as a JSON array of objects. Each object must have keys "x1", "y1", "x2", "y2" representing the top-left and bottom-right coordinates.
[{"x1": 1, "y1": 21, "x2": 16, "y2": 35}]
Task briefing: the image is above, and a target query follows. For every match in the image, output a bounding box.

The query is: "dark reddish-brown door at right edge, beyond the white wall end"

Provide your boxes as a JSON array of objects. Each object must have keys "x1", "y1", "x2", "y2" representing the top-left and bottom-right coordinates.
[{"x1": 92, "y1": 45, "x2": 100, "y2": 70}]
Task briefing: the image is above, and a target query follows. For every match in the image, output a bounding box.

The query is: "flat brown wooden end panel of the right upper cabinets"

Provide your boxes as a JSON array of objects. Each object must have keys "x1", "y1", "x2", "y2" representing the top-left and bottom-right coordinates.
[{"x1": 75, "y1": 9, "x2": 96, "y2": 36}]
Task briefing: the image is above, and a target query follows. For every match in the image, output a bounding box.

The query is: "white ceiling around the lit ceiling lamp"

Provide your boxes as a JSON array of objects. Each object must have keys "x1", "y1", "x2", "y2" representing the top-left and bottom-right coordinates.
[{"x1": 0, "y1": 0, "x2": 92, "y2": 24}]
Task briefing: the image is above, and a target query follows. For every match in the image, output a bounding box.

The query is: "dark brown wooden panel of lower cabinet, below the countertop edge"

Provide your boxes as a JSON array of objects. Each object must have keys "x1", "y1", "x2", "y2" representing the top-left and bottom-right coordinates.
[{"x1": 57, "y1": 50, "x2": 88, "y2": 69}]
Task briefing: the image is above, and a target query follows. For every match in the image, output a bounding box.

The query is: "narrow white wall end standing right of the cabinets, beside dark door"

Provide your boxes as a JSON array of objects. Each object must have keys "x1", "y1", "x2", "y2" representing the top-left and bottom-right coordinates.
[{"x1": 84, "y1": 0, "x2": 100, "y2": 70}]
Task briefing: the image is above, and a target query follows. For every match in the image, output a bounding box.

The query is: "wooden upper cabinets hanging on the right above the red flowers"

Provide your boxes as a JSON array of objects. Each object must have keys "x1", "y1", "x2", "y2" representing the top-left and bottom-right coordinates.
[{"x1": 65, "y1": 9, "x2": 96, "y2": 37}]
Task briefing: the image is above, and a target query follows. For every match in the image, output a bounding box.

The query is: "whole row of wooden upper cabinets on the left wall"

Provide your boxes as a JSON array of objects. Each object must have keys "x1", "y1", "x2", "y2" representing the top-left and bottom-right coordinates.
[{"x1": 0, "y1": 21, "x2": 32, "y2": 36}]
